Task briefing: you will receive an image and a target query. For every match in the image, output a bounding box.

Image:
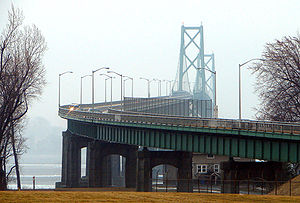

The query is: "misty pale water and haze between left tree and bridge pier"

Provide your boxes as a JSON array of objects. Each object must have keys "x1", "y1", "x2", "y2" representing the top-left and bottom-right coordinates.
[{"x1": 7, "y1": 117, "x2": 64, "y2": 189}]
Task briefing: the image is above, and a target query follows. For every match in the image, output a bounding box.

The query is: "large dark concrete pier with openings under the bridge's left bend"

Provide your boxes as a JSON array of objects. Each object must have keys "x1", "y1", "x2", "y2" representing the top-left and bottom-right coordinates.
[{"x1": 56, "y1": 131, "x2": 137, "y2": 188}]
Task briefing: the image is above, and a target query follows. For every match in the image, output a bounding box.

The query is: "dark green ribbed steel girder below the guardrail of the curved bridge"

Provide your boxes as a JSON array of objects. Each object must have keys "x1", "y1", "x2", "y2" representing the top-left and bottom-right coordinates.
[{"x1": 68, "y1": 118, "x2": 300, "y2": 162}]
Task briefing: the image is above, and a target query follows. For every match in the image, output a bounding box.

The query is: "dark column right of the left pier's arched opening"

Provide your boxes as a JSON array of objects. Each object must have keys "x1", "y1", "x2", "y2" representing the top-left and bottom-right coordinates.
[{"x1": 125, "y1": 149, "x2": 137, "y2": 188}]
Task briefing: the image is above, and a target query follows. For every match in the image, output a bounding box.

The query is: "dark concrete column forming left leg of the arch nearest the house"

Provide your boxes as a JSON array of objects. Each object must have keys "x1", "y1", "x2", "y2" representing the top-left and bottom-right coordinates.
[{"x1": 136, "y1": 148, "x2": 152, "y2": 192}]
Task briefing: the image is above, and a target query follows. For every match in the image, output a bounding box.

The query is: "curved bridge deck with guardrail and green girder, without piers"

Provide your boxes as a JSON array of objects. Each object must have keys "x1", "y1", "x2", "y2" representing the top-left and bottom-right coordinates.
[{"x1": 59, "y1": 102, "x2": 300, "y2": 162}]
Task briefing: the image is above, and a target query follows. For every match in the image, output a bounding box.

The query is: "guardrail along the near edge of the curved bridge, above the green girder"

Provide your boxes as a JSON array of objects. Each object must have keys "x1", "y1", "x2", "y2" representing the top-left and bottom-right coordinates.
[{"x1": 59, "y1": 105, "x2": 300, "y2": 135}]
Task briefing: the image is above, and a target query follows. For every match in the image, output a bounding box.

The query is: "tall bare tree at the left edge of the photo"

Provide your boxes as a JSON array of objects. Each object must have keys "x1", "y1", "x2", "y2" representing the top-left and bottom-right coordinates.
[{"x1": 0, "y1": 6, "x2": 46, "y2": 190}]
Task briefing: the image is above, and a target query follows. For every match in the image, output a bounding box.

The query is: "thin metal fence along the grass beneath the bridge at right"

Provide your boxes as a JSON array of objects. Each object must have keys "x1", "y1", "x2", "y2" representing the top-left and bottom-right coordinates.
[{"x1": 150, "y1": 178, "x2": 300, "y2": 196}]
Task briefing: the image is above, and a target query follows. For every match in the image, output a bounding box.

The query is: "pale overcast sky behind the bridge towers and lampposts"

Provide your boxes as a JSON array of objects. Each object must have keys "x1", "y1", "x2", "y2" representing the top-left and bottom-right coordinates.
[{"x1": 0, "y1": 0, "x2": 300, "y2": 128}]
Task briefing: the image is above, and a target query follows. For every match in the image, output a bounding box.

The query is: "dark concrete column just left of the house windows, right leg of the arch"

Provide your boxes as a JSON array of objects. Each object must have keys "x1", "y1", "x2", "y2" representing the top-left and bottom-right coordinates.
[{"x1": 177, "y1": 152, "x2": 193, "y2": 192}]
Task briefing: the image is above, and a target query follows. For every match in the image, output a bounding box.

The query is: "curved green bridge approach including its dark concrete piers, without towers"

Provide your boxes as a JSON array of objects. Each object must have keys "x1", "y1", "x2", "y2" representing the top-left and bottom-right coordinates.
[{"x1": 57, "y1": 98, "x2": 300, "y2": 191}]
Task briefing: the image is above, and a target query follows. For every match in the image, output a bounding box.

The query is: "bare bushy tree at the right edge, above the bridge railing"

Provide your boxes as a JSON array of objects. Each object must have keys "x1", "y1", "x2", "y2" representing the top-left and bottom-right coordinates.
[{"x1": 251, "y1": 35, "x2": 300, "y2": 122}]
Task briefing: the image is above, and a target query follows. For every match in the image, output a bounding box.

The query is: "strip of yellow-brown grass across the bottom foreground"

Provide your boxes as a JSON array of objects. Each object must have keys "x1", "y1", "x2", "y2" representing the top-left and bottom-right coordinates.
[{"x1": 0, "y1": 191, "x2": 300, "y2": 203}]
